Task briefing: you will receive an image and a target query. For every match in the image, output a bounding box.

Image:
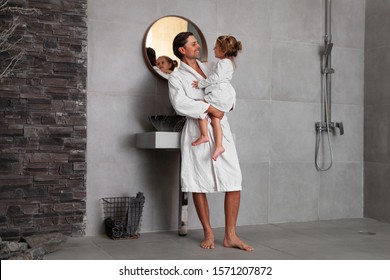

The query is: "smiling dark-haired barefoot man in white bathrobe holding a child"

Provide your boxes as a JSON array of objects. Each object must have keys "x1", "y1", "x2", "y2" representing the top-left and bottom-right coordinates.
[{"x1": 169, "y1": 32, "x2": 253, "y2": 251}]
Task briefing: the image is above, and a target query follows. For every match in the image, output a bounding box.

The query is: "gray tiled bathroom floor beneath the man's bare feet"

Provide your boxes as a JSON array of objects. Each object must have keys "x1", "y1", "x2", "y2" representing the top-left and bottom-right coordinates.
[{"x1": 45, "y1": 218, "x2": 390, "y2": 260}]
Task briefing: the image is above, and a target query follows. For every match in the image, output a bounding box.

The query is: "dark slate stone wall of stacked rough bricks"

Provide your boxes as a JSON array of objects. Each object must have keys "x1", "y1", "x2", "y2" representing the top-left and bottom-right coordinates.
[{"x1": 0, "y1": 0, "x2": 87, "y2": 240}]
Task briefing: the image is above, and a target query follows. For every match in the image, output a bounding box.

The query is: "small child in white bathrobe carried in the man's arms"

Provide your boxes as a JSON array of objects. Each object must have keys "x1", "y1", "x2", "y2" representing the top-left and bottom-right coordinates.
[{"x1": 192, "y1": 35, "x2": 242, "y2": 160}]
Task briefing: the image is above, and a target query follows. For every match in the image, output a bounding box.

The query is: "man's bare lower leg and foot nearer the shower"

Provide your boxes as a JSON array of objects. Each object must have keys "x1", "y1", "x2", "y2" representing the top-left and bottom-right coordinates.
[{"x1": 223, "y1": 191, "x2": 253, "y2": 251}]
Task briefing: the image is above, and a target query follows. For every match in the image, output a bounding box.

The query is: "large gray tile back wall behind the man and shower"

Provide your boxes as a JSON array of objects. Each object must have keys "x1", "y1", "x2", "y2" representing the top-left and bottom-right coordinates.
[{"x1": 87, "y1": 0, "x2": 365, "y2": 235}]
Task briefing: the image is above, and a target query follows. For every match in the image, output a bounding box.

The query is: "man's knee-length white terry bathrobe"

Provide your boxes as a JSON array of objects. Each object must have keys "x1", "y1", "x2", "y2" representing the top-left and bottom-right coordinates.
[{"x1": 169, "y1": 61, "x2": 242, "y2": 193}]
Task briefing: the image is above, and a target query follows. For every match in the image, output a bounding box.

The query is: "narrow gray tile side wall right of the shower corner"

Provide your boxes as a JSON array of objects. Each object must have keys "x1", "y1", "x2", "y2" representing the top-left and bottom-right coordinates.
[{"x1": 364, "y1": 0, "x2": 390, "y2": 222}]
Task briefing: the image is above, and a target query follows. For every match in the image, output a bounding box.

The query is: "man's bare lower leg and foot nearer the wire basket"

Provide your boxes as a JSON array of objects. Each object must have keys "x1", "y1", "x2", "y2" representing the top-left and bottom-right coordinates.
[{"x1": 192, "y1": 193, "x2": 215, "y2": 249}]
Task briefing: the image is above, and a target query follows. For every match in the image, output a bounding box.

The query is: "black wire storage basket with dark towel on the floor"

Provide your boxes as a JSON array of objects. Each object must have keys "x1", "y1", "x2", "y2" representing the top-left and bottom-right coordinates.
[{"x1": 102, "y1": 192, "x2": 145, "y2": 239}]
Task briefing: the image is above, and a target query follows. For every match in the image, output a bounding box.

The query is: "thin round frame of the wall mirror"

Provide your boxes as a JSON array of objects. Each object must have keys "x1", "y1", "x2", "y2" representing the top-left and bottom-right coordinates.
[{"x1": 142, "y1": 15, "x2": 208, "y2": 80}]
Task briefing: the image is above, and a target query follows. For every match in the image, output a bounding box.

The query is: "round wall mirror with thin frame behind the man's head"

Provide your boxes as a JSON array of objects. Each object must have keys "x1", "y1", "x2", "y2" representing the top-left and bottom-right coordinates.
[{"x1": 142, "y1": 16, "x2": 207, "y2": 79}]
